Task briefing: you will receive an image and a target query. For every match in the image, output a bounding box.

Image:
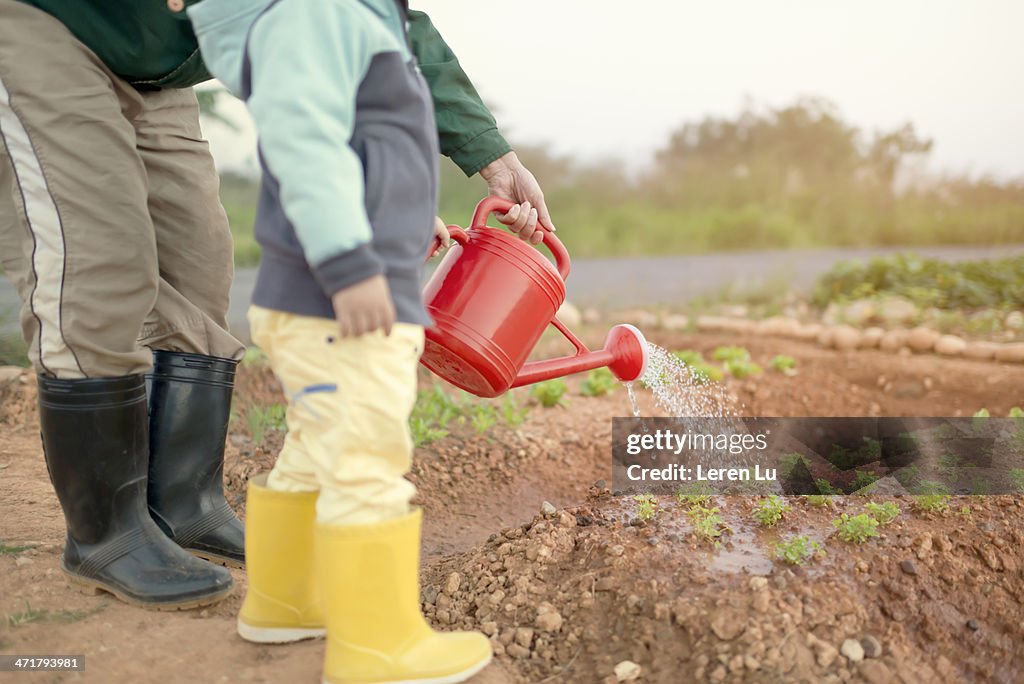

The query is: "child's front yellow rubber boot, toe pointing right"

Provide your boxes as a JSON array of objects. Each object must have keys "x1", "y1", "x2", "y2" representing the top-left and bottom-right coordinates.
[{"x1": 315, "y1": 510, "x2": 492, "y2": 684}]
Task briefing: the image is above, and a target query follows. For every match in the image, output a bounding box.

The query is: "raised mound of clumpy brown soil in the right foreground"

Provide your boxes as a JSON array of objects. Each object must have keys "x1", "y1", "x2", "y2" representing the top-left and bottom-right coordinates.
[{"x1": 424, "y1": 494, "x2": 1024, "y2": 682}]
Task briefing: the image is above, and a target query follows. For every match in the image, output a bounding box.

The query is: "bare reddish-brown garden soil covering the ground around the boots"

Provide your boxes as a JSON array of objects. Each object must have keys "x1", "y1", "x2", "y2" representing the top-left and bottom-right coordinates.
[{"x1": 0, "y1": 330, "x2": 1024, "y2": 684}]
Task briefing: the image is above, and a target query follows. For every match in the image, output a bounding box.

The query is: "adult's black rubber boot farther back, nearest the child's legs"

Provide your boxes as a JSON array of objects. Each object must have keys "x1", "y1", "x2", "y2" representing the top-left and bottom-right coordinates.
[{"x1": 146, "y1": 351, "x2": 246, "y2": 567}]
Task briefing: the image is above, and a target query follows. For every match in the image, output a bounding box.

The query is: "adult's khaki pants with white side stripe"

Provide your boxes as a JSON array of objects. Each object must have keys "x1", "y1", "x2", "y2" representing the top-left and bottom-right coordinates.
[{"x1": 0, "y1": 0, "x2": 243, "y2": 378}]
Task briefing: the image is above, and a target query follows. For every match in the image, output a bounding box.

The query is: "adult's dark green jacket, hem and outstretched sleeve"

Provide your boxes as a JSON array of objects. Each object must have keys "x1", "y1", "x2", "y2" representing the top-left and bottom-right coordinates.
[{"x1": 23, "y1": 0, "x2": 511, "y2": 175}]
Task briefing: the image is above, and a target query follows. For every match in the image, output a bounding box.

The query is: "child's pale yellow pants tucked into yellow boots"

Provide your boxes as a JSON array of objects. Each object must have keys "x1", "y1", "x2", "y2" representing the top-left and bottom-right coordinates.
[{"x1": 249, "y1": 306, "x2": 423, "y2": 525}]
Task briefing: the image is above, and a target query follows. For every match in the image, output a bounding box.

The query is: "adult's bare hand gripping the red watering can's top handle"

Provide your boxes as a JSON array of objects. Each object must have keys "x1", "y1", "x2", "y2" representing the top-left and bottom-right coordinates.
[{"x1": 480, "y1": 152, "x2": 555, "y2": 245}]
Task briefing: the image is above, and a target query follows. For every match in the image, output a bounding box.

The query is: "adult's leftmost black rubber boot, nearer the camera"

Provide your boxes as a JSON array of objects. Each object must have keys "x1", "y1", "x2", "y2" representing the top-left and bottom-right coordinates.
[{"x1": 39, "y1": 375, "x2": 233, "y2": 610}]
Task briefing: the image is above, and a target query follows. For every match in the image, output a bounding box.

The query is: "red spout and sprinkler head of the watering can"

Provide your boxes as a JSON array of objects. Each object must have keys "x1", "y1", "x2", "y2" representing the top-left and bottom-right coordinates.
[{"x1": 512, "y1": 318, "x2": 647, "y2": 387}]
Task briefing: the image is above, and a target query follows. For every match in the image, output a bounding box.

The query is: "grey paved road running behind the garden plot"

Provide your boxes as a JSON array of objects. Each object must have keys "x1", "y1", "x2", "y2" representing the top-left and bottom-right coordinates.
[{"x1": 0, "y1": 245, "x2": 1024, "y2": 344}]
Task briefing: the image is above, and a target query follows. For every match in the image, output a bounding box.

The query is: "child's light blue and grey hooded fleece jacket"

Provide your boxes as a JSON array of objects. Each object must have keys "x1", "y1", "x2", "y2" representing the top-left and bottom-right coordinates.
[{"x1": 188, "y1": 0, "x2": 438, "y2": 324}]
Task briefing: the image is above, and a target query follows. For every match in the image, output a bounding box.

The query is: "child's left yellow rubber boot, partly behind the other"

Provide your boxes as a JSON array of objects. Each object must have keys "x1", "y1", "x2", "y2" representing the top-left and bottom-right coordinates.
[{"x1": 239, "y1": 475, "x2": 326, "y2": 644}]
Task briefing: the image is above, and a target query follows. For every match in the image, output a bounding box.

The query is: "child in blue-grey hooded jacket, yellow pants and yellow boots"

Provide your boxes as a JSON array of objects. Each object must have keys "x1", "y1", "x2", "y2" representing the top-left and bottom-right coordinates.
[{"x1": 188, "y1": 0, "x2": 492, "y2": 683}]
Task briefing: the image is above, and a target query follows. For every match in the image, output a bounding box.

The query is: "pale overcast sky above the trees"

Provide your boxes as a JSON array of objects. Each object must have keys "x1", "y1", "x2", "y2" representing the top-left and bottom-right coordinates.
[{"x1": 201, "y1": 0, "x2": 1024, "y2": 177}]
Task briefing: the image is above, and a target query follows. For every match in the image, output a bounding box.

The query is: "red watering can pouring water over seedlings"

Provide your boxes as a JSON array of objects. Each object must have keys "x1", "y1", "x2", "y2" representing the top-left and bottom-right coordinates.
[{"x1": 420, "y1": 197, "x2": 647, "y2": 397}]
